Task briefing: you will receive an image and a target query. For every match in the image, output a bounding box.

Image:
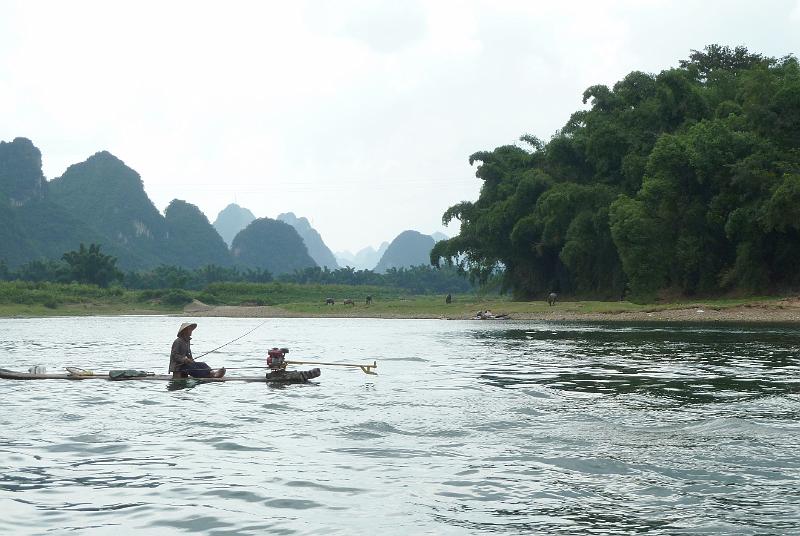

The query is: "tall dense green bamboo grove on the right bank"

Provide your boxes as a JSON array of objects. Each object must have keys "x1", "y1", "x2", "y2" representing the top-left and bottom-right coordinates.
[{"x1": 431, "y1": 45, "x2": 800, "y2": 301}]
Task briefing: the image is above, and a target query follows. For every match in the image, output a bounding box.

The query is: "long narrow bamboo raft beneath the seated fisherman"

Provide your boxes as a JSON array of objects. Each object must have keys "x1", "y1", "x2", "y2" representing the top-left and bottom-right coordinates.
[{"x1": 0, "y1": 368, "x2": 320, "y2": 383}]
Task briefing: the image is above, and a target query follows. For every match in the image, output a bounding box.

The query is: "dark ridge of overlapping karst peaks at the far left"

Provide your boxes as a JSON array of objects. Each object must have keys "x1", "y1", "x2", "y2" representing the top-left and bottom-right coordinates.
[{"x1": 0, "y1": 142, "x2": 232, "y2": 270}]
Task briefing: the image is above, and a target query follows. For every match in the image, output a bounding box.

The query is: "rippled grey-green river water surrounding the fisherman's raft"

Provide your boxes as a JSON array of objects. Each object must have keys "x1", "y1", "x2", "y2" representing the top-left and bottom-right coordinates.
[{"x1": 0, "y1": 317, "x2": 800, "y2": 535}]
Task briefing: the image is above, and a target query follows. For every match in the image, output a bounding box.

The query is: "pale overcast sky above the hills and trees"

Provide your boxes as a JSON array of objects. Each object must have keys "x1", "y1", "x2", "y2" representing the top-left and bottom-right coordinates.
[{"x1": 0, "y1": 0, "x2": 800, "y2": 251}]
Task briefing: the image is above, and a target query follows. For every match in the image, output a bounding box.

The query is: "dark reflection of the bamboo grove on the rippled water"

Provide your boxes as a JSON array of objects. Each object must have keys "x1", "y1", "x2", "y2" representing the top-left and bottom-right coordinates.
[{"x1": 473, "y1": 324, "x2": 800, "y2": 403}]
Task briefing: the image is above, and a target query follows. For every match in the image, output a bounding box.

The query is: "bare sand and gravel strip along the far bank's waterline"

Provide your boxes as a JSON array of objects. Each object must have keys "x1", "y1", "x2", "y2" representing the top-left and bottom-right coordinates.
[{"x1": 184, "y1": 298, "x2": 800, "y2": 323}]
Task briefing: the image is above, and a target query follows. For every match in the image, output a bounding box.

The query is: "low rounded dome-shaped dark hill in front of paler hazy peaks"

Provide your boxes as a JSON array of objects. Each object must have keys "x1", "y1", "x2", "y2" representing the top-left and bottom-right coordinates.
[{"x1": 231, "y1": 218, "x2": 316, "y2": 275}]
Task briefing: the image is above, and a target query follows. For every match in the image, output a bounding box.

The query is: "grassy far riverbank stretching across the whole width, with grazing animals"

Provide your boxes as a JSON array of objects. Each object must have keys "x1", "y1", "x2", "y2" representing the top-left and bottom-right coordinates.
[{"x1": 0, "y1": 282, "x2": 800, "y2": 322}]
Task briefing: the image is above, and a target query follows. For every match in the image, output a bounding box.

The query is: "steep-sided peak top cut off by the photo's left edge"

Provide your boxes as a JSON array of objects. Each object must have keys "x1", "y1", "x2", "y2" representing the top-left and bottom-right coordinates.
[{"x1": 0, "y1": 138, "x2": 46, "y2": 207}]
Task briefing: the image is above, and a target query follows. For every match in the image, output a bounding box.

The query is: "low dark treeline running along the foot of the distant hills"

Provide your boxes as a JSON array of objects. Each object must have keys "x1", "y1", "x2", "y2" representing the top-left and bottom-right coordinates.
[{"x1": 0, "y1": 244, "x2": 473, "y2": 294}]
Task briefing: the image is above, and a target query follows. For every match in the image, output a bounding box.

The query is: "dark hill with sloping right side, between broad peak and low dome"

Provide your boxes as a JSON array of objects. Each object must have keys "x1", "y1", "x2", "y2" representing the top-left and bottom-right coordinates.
[{"x1": 164, "y1": 199, "x2": 232, "y2": 268}]
